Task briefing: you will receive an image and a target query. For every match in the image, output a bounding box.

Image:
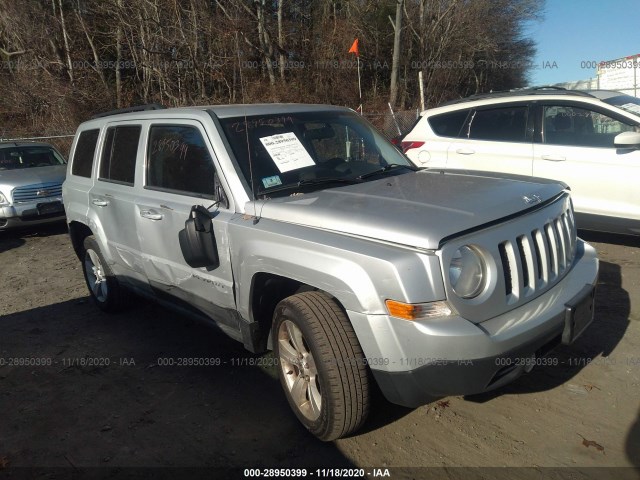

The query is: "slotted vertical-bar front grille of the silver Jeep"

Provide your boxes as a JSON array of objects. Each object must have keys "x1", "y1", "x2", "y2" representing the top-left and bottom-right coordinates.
[{"x1": 498, "y1": 208, "x2": 577, "y2": 305}]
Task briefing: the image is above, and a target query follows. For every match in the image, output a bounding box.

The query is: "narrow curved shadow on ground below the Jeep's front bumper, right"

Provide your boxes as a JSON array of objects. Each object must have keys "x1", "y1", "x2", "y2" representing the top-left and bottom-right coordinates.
[{"x1": 465, "y1": 261, "x2": 631, "y2": 403}]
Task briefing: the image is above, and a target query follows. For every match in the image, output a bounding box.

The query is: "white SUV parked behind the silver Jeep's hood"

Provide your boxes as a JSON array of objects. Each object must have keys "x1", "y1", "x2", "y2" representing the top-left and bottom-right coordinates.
[{"x1": 402, "y1": 88, "x2": 640, "y2": 235}]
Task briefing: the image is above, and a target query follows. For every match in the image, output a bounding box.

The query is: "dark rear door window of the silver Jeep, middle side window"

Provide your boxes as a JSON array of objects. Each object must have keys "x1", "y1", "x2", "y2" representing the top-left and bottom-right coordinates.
[{"x1": 100, "y1": 125, "x2": 141, "y2": 185}]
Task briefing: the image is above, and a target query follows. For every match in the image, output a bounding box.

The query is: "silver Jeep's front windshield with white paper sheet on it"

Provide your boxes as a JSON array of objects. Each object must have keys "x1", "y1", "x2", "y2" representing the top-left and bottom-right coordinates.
[{"x1": 221, "y1": 111, "x2": 415, "y2": 197}]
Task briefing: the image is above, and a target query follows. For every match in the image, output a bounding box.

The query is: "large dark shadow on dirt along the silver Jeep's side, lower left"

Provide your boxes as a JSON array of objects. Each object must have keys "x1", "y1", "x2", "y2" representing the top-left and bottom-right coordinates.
[{"x1": 0, "y1": 298, "x2": 353, "y2": 470}]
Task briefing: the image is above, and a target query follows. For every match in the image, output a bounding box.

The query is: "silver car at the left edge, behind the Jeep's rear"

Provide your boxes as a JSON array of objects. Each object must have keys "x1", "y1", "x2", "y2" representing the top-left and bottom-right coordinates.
[{"x1": 0, "y1": 142, "x2": 67, "y2": 230}]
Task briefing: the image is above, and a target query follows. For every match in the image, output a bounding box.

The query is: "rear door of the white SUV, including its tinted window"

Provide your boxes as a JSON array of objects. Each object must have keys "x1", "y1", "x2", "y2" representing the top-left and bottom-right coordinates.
[{"x1": 447, "y1": 103, "x2": 533, "y2": 175}]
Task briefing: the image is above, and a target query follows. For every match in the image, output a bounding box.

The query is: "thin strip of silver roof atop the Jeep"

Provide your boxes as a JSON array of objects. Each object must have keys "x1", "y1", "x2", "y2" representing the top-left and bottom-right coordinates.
[{"x1": 92, "y1": 103, "x2": 352, "y2": 120}]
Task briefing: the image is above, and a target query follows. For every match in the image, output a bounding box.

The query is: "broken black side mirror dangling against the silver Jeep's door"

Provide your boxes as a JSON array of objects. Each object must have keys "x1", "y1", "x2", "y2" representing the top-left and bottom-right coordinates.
[{"x1": 178, "y1": 205, "x2": 220, "y2": 269}]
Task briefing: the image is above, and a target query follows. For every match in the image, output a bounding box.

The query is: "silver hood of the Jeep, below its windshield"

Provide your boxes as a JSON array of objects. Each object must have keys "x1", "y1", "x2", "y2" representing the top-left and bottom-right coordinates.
[{"x1": 245, "y1": 170, "x2": 567, "y2": 249}]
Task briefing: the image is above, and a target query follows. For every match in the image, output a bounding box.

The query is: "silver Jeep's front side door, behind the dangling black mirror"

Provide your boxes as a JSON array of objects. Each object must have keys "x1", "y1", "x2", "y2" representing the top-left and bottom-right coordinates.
[{"x1": 135, "y1": 120, "x2": 237, "y2": 329}]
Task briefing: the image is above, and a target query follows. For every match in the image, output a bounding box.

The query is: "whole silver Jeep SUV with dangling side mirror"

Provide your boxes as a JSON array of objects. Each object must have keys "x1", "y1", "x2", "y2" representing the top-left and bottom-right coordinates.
[{"x1": 63, "y1": 104, "x2": 598, "y2": 440}]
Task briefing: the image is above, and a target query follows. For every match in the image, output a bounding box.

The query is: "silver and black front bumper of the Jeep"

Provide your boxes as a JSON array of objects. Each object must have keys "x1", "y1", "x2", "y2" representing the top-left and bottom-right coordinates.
[{"x1": 348, "y1": 242, "x2": 598, "y2": 407}]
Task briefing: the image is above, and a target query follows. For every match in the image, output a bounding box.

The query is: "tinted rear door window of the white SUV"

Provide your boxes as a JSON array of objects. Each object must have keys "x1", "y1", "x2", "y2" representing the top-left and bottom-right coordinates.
[{"x1": 469, "y1": 106, "x2": 528, "y2": 142}]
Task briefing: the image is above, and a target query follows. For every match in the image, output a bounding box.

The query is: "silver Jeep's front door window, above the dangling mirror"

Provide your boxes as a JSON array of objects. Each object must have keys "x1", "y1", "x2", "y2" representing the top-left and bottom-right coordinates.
[{"x1": 146, "y1": 125, "x2": 216, "y2": 197}]
